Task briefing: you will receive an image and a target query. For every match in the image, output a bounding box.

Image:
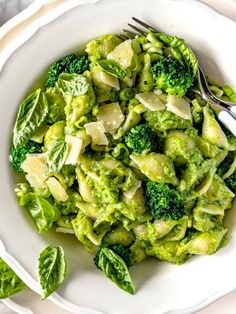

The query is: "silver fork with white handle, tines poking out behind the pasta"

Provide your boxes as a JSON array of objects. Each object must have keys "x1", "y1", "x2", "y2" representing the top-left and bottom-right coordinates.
[{"x1": 123, "y1": 17, "x2": 236, "y2": 136}]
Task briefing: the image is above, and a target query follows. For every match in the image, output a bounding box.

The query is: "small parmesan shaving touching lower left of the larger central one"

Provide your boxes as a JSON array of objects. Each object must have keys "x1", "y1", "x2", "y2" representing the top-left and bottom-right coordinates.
[{"x1": 84, "y1": 121, "x2": 108, "y2": 145}]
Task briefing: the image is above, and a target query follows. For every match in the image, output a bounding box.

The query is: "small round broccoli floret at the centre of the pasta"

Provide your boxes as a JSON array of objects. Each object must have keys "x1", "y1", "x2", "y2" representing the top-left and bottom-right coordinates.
[{"x1": 125, "y1": 123, "x2": 156, "y2": 154}]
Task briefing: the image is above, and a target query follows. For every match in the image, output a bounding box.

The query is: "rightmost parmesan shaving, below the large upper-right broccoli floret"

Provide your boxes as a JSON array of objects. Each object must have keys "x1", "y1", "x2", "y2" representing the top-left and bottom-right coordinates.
[{"x1": 166, "y1": 95, "x2": 191, "y2": 120}]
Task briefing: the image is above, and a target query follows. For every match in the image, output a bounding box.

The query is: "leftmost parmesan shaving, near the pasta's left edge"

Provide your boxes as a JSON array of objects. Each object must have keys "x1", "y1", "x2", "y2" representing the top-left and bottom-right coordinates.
[{"x1": 21, "y1": 154, "x2": 47, "y2": 188}]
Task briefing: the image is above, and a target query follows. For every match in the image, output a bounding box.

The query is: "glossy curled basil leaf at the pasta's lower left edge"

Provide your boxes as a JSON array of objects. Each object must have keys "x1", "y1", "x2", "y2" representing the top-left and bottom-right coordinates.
[{"x1": 20, "y1": 193, "x2": 60, "y2": 233}]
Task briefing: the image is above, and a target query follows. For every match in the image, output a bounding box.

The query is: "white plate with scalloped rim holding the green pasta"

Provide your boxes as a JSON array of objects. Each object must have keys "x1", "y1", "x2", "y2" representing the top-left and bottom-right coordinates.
[{"x1": 0, "y1": 0, "x2": 236, "y2": 314}]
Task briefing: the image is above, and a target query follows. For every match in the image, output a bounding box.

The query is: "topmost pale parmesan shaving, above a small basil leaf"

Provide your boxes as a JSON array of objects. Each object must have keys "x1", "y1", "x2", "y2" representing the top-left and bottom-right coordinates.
[{"x1": 107, "y1": 39, "x2": 134, "y2": 69}]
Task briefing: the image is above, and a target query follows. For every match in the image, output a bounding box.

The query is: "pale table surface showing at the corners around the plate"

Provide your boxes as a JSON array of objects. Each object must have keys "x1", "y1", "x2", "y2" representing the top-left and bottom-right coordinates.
[{"x1": 0, "y1": 0, "x2": 236, "y2": 314}]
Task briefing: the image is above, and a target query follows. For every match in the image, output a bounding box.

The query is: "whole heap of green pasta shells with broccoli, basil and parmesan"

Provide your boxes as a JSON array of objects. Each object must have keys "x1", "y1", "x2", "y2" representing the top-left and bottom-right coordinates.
[{"x1": 11, "y1": 33, "x2": 236, "y2": 294}]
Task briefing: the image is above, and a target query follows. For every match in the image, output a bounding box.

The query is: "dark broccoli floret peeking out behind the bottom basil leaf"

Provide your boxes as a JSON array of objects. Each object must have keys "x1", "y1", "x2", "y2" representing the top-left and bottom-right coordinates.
[{"x1": 94, "y1": 243, "x2": 133, "y2": 268}]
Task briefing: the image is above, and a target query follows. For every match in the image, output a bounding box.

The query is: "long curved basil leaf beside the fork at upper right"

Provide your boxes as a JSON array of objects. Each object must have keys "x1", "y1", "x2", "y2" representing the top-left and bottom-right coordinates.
[{"x1": 155, "y1": 33, "x2": 198, "y2": 77}]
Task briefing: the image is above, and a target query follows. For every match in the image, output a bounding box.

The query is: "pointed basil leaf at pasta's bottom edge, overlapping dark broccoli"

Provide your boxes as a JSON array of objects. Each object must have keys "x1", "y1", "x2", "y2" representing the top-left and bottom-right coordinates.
[{"x1": 98, "y1": 248, "x2": 135, "y2": 294}]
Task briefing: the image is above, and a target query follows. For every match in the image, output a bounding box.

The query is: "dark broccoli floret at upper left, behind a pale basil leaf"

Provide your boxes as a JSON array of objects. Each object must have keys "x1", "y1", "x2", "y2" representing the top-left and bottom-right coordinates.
[{"x1": 45, "y1": 54, "x2": 89, "y2": 87}]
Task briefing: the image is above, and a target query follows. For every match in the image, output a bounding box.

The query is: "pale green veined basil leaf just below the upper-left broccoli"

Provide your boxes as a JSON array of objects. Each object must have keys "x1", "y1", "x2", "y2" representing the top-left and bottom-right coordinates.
[{"x1": 57, "y1": 73, "x2": 89, "y2": 96}]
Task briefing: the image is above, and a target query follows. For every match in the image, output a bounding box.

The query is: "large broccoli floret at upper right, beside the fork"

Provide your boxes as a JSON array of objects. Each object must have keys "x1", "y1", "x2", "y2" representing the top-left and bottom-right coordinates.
[{"x1": 150, "y1": 56, "x2": 193, "y2": 97}]
